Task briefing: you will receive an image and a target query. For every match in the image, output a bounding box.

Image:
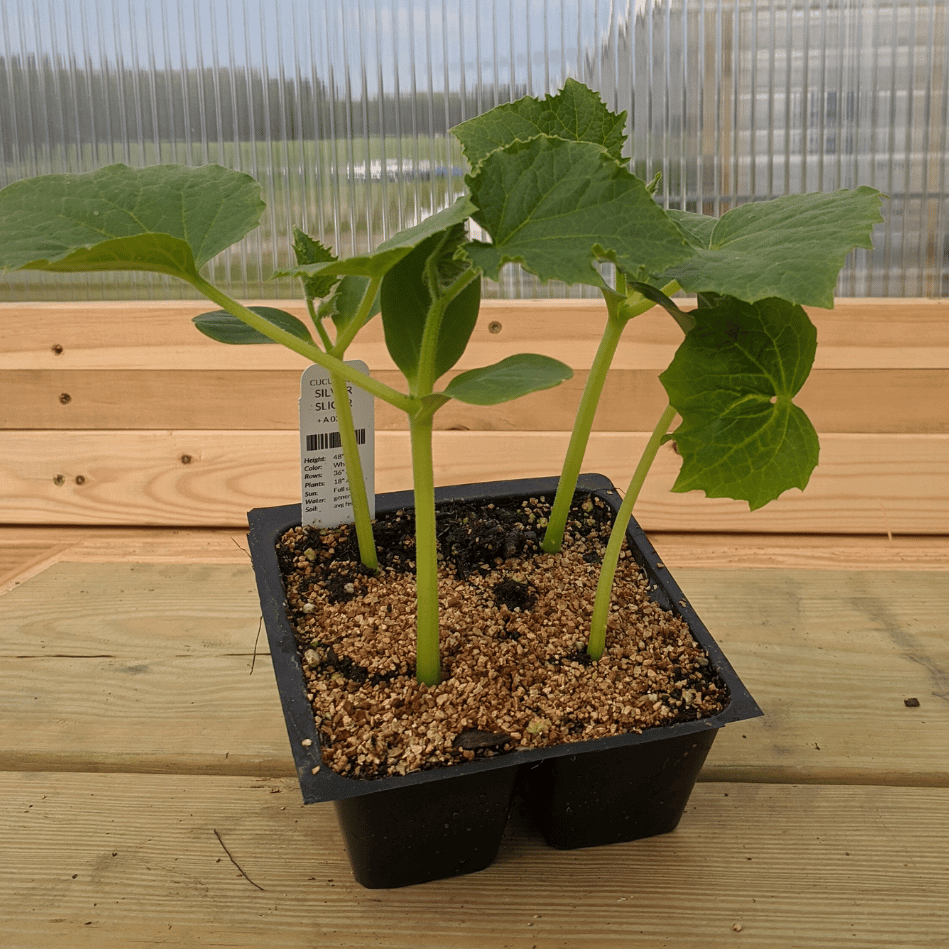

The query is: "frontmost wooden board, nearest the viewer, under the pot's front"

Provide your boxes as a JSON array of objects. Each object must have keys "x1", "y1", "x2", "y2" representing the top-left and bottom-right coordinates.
[{"x1": 0, "y1": 774, "x2": 949, "y2": 949}]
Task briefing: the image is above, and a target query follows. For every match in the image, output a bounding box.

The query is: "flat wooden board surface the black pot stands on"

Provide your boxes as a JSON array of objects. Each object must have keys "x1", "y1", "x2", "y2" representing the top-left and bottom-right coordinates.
[{"x1": 0, "y1": 527, "x2": 949, "y2": 949}]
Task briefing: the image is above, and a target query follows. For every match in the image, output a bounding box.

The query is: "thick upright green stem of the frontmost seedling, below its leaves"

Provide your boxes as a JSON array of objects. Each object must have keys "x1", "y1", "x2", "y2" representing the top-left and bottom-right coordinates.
[{"x1": 409, "y1": 410, "x2": 441, "y2": 685}]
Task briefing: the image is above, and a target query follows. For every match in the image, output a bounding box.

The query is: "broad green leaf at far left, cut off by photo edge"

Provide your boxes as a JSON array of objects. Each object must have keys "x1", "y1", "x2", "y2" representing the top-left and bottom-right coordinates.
[{"x1": 0, "y1": 165, "x2": 265, "y2": 279}]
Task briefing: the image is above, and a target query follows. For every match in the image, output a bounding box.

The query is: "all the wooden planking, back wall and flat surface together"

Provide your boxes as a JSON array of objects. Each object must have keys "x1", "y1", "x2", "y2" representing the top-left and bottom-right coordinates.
[{"x1": 0, "y1": 300, "x2": 949, "y2": 949}]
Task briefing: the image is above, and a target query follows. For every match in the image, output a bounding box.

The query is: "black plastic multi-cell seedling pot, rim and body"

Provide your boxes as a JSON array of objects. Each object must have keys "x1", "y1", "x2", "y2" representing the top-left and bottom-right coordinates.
[{"x1": 248, "y1": 475, "x2": 761, "y2": 888}]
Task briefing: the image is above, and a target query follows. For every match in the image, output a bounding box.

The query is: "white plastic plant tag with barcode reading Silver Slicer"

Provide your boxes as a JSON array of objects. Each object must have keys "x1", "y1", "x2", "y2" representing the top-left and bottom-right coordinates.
[{"x1": 300, "y1": 360, "x2": 376, "y2": 527}]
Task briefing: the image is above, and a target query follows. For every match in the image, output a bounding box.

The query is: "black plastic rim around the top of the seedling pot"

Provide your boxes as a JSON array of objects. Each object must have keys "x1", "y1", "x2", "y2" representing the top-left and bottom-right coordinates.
[{"x1": 247, "y1": 474, "x2": 763, "y2": 804}]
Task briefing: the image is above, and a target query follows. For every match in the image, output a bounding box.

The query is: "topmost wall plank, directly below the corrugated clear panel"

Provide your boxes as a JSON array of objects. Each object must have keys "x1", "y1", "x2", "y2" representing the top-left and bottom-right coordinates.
[{"x1": 0, "y1": 299, "x2": 949, "y2": 370}]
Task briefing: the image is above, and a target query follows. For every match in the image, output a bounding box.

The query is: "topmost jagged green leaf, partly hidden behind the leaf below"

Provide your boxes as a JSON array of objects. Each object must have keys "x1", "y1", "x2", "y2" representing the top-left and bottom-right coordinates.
[{"x1": 452, "y1": 79, "x2": 626, "y2": 168}]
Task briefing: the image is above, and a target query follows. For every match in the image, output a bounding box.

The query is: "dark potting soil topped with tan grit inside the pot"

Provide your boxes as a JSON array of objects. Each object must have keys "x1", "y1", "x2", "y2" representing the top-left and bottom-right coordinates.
[{"x1": 277, "y1": 494, "x2": 728, "y2": 778}]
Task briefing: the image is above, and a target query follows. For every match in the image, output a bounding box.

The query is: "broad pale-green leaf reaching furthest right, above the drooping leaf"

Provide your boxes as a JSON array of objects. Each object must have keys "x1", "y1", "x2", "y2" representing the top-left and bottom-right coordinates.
[{"x1": 662, "y1": 187, "x2": 883, "y2": 307}]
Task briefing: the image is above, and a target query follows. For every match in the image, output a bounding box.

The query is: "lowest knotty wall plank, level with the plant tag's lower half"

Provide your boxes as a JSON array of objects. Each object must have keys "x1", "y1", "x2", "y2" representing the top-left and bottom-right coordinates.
[{"x1": 0, "y1": 431, "x2": 949, "y2": 534}]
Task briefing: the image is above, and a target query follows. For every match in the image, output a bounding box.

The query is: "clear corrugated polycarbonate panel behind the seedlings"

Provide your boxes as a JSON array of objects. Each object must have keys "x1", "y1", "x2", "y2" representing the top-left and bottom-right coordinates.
[{"x1": 0, "y1": 0, "x2": 949, "y2": 300}]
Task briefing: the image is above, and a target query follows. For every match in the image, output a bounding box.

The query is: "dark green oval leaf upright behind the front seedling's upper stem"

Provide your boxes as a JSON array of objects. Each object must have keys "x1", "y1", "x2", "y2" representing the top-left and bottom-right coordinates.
[{"x1": 379, "y1": 224, "x2": 481, "y2": 383}]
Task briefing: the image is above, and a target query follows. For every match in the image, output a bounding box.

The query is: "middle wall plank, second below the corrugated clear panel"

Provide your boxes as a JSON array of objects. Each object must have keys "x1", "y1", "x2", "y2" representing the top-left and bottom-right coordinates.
[{"x1": 0, "y1": 366, "x2": 949, "y2": 434}]
